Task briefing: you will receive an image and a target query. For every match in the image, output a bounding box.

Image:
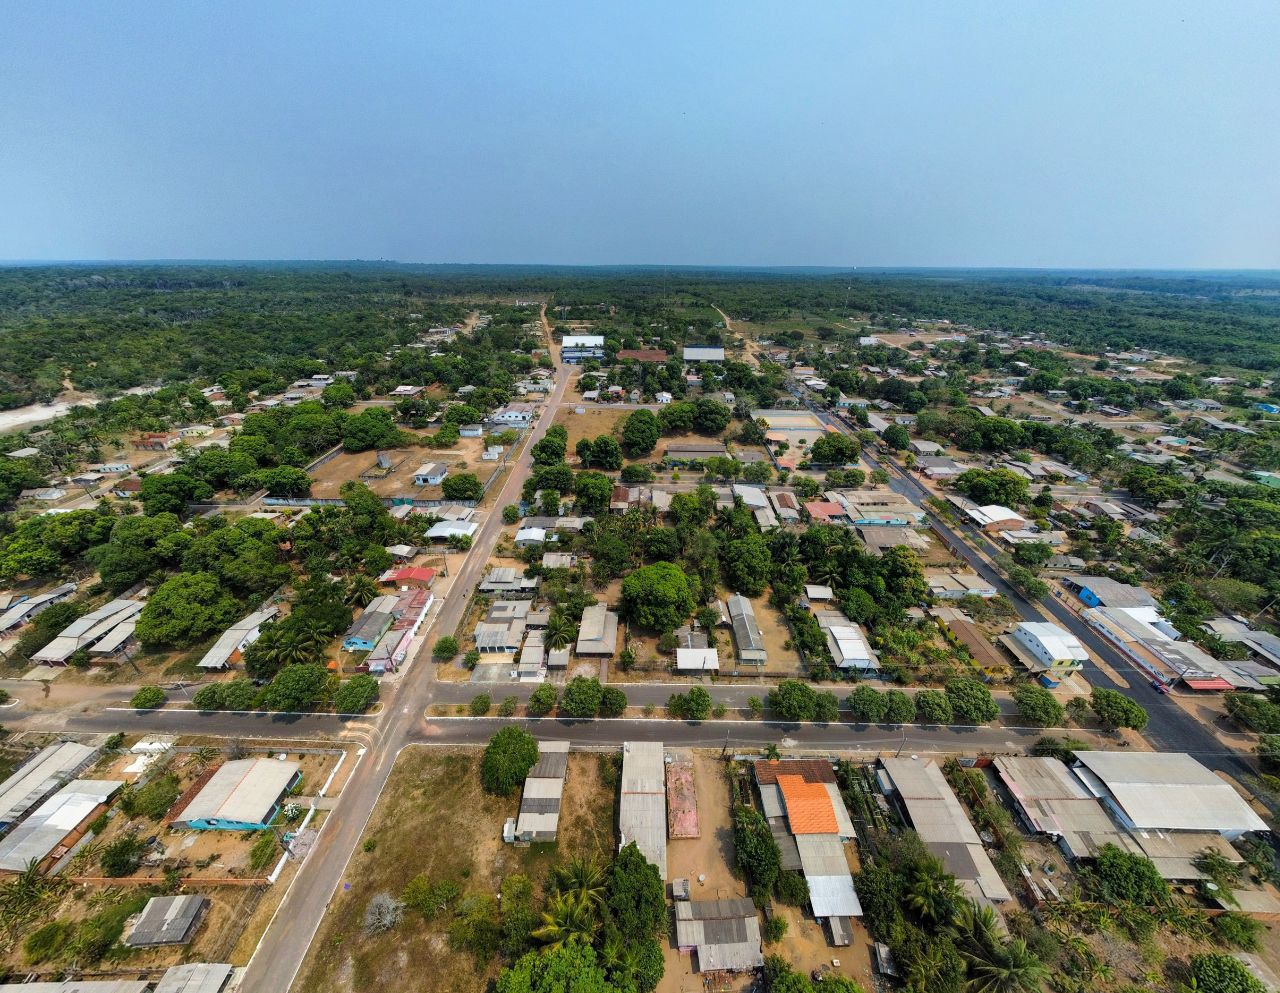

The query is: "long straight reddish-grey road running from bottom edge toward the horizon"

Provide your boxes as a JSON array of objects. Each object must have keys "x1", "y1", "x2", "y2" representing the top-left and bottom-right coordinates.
[{"x1": 238, "y1": 306, "x2": 570, "y2": 993}]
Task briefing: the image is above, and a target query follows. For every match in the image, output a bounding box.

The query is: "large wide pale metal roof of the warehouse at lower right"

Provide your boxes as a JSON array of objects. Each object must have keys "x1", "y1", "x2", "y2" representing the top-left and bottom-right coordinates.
[{"x1": 1074, "y1": 751, "x2": 1267, "y2": 838}]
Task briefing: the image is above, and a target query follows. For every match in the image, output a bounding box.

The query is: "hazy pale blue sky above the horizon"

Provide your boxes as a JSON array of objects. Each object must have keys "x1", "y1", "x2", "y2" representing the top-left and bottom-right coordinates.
[{"x1": 0, "y1": 0, "x2": 1280, "y2": 267}]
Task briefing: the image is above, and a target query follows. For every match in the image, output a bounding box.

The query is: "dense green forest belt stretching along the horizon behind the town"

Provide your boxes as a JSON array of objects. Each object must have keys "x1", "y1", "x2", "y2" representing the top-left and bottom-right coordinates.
[{"x1": 0, "y1": 262, "x2": 1280, "y2": 409}]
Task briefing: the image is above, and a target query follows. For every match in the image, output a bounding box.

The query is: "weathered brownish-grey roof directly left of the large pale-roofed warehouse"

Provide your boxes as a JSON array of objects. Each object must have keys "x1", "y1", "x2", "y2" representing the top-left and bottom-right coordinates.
[{"x1": 995, "y1": 755, "x2": 1142, "y2": 859}]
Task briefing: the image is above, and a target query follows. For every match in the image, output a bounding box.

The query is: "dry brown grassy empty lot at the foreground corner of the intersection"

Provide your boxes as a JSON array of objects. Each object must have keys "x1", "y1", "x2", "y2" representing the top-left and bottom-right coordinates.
[{"x1": 294, "y1": 749, "x2": 614, "y2": 993}]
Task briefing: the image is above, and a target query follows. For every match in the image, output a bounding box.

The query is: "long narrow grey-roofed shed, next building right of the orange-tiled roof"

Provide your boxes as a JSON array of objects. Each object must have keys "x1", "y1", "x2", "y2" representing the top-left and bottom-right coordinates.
[{"x1": 881, "y1": 759, "x2": 1012, "y2": 902}]
